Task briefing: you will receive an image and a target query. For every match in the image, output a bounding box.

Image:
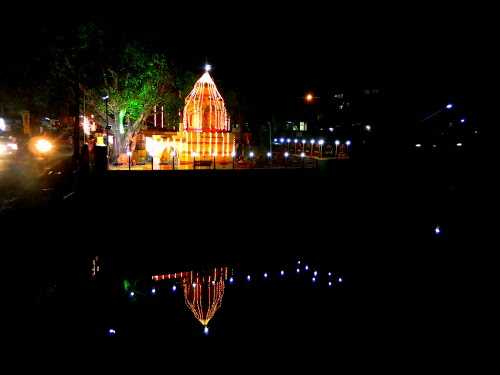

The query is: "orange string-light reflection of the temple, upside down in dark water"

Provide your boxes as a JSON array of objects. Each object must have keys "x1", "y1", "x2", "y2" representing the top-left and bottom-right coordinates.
[{"x1": 153, "y1": 267, "x2": 230, "y2": 333}]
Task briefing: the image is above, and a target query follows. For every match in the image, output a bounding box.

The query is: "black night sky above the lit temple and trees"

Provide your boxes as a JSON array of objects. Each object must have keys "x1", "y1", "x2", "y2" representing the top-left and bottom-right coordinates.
[{"x1": 2, "y1": 3, "x2": 488, "y2": 122}]
